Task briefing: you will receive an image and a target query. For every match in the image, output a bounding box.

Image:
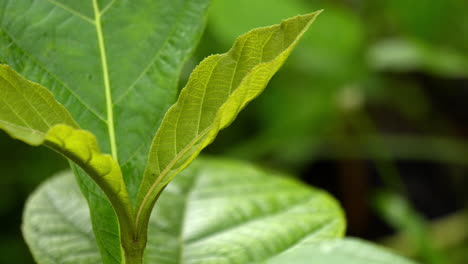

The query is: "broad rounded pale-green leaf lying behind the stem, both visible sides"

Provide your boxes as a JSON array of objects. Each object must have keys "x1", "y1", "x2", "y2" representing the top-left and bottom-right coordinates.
[{"x1": 23, "y1": 158, "x2": 344, "y2": 264}]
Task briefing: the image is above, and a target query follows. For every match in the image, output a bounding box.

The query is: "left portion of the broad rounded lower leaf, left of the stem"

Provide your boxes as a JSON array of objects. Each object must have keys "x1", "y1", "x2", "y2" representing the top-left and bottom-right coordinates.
[{"x1": 22, "y1": 171, "x2": 102, "y2": 264}]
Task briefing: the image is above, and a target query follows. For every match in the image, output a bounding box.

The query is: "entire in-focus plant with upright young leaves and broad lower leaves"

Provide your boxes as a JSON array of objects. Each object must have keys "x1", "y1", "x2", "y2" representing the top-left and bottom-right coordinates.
[{"x1": 0, "y1": 0, "x2": 416, "y2": 264}]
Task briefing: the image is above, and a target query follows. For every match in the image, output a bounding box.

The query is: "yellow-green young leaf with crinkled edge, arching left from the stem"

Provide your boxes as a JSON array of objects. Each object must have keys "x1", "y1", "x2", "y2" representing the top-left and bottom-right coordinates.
[{"x1": 0, "y1": 65, "x2": 133, "y2": 241}]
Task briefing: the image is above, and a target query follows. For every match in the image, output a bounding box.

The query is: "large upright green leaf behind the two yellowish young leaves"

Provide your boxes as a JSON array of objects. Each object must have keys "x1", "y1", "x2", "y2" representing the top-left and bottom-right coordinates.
[{"x1": 0, "y1": 0, "x2": 210, "y2": 264}]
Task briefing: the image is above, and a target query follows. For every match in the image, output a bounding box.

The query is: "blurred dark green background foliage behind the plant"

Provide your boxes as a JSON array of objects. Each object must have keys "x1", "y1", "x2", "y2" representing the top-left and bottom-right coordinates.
[{"x1": 0, "y1": 0, "x2": 468, "y2": 264}]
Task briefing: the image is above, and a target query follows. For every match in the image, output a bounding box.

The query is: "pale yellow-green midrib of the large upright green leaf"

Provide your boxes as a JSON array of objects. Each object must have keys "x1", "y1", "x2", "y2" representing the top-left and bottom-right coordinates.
[{"x1": 93, "y1": 0, "x2": 118, "y2": 162}]
